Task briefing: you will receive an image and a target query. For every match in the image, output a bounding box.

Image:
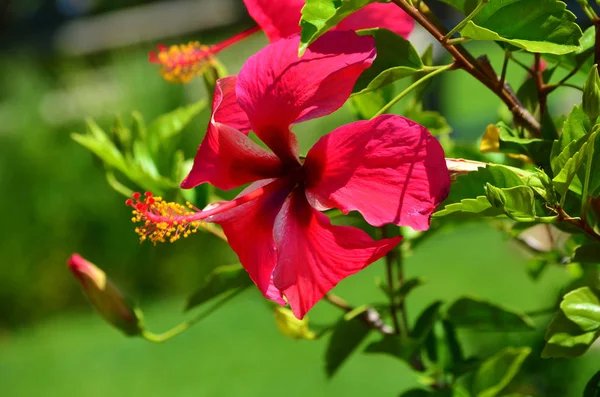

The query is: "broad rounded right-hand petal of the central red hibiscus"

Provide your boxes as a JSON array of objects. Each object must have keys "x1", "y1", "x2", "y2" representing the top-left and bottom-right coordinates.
[{"x1": 304, "y1": 115, "x2": 450, "y2": 230}]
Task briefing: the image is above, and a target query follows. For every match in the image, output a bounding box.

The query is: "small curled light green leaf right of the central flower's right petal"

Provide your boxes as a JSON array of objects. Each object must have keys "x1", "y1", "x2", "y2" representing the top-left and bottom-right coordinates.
[{"x1": 486, "y1": 183, "x2": 536, "y2": 222}]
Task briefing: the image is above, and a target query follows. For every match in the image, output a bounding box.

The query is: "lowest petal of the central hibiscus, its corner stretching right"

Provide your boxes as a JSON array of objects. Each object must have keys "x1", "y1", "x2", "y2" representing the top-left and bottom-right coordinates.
[{"x1": 273, "y1": 189, "x2": 402, "y2": 319}]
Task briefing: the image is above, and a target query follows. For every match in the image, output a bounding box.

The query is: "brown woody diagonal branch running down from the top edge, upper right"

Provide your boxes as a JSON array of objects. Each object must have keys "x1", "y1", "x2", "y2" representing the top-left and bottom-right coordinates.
[{"x1": 392, "y1": 0, "x2": 541, "y2": 136}]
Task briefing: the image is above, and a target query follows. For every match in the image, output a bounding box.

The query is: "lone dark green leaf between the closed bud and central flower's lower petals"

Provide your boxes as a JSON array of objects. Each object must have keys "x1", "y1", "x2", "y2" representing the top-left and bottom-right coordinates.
[{"x1": 185, "y1": 264, "x2": 252, "y2": 310}]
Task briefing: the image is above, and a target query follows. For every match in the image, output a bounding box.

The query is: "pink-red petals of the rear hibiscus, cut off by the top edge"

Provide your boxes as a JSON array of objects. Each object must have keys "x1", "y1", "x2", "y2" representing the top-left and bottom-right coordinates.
[{"x1": 244, "y1": 0, "x2": 414, "y2": 43}]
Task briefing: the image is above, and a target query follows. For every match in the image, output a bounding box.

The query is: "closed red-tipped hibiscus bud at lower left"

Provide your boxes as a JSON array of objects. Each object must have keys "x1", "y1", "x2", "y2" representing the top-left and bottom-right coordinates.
[{"x1": 67, "y1": 254, "x2": 143, "y2": 336}]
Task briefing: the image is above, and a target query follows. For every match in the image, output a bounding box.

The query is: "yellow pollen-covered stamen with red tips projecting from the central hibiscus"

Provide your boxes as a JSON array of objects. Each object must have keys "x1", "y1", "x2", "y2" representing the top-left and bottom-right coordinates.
[{"x1": 125, "y1": 183, "x2": 276, "y2": 244}]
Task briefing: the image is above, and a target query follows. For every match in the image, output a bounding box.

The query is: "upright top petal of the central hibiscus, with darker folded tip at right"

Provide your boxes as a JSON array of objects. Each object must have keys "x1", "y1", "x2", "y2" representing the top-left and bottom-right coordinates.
[{"x1": 236, "y1": 31, "x2": 375, "y2": 163}]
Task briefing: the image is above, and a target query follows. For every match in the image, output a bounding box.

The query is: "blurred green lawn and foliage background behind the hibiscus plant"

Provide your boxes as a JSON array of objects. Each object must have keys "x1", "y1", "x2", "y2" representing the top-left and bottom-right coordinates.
[{"x1": 0, "y1": 0, "x2": 600, "y2": 397}]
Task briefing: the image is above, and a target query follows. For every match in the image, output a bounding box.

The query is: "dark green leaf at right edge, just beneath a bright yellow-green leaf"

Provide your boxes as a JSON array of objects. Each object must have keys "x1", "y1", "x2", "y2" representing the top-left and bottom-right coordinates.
[{"x1": 542, "y1": 311, "x2": 598, "y2": 358}]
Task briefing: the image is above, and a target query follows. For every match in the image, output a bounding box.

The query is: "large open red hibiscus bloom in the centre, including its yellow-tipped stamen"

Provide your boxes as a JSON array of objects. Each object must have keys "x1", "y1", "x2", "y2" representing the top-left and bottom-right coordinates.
[{"x1": 129, "y1": 31, "x2": 450, "y2": 318}]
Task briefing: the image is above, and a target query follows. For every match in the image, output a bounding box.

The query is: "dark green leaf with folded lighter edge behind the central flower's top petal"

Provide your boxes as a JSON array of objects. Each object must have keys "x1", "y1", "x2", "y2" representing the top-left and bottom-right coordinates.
[{"x1": 354, "y1": 28, "x2": 429, "y2": 93}]
